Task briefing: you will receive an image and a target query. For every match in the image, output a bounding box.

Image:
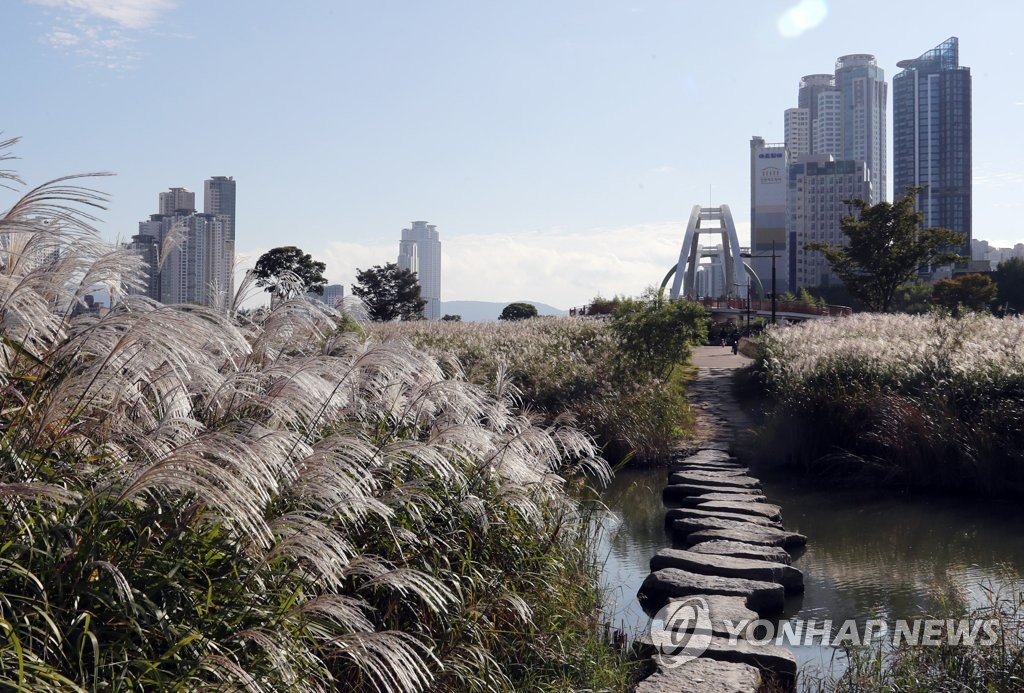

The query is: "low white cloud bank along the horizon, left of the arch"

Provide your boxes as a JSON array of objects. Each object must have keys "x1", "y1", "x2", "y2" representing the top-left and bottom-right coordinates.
[{"x1": 240, "y1": 219, "x2": 749, "y2": 309}]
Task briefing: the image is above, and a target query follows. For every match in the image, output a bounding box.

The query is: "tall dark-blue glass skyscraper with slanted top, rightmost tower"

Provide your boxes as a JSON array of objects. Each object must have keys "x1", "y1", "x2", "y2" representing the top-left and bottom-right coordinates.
[{"x1": 893, "y1": 36, "x2": 971, "y2": 256}]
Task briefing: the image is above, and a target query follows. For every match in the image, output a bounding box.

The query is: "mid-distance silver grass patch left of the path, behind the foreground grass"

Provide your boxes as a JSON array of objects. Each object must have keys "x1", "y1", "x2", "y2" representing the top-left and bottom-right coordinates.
[{"x1": 373, "y1": 317, "x2": 692, "y2": 464}]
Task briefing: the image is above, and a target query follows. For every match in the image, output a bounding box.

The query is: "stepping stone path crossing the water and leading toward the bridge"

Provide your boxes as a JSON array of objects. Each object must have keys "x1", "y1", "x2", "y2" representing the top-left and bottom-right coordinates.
[{"x1": 636, "y1": 347, "x2": 807, "y2": 693}]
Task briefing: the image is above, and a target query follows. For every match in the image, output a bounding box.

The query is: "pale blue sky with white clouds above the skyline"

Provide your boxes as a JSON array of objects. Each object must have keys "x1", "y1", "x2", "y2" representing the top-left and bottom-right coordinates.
[{"x1": 0, "y1": 0, "x2": 1024, "y2": 308}]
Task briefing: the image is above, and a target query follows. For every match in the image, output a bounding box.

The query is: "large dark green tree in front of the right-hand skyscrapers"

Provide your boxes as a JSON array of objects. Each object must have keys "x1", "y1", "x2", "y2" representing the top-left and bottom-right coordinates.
[{"x1": 804, "y1": 188, "x2": 964, "y2": 312}]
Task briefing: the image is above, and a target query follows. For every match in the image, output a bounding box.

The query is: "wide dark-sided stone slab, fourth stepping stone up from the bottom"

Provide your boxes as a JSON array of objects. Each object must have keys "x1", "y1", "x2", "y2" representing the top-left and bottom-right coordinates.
[{"x1": 637, "y1": 568, "x2": 785, "y2": 615}]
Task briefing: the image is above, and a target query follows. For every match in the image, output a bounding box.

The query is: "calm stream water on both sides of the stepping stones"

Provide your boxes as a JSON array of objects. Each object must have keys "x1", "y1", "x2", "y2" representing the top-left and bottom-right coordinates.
[{"x1": 600, "y1": 462, "x2": 1024, "y2": 676}]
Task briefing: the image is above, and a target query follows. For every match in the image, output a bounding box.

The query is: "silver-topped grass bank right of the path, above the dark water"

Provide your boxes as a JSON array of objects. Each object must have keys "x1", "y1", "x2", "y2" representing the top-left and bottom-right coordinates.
[{"x1": 756, "y1": 314, "x2": 1024, "y2": 493}]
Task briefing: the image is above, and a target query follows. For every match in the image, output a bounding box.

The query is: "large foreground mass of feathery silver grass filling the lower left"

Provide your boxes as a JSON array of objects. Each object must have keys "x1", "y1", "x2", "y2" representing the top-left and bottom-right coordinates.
[{"x1": 0, "y1": 141, "x2": 627, "y2": 691}]
